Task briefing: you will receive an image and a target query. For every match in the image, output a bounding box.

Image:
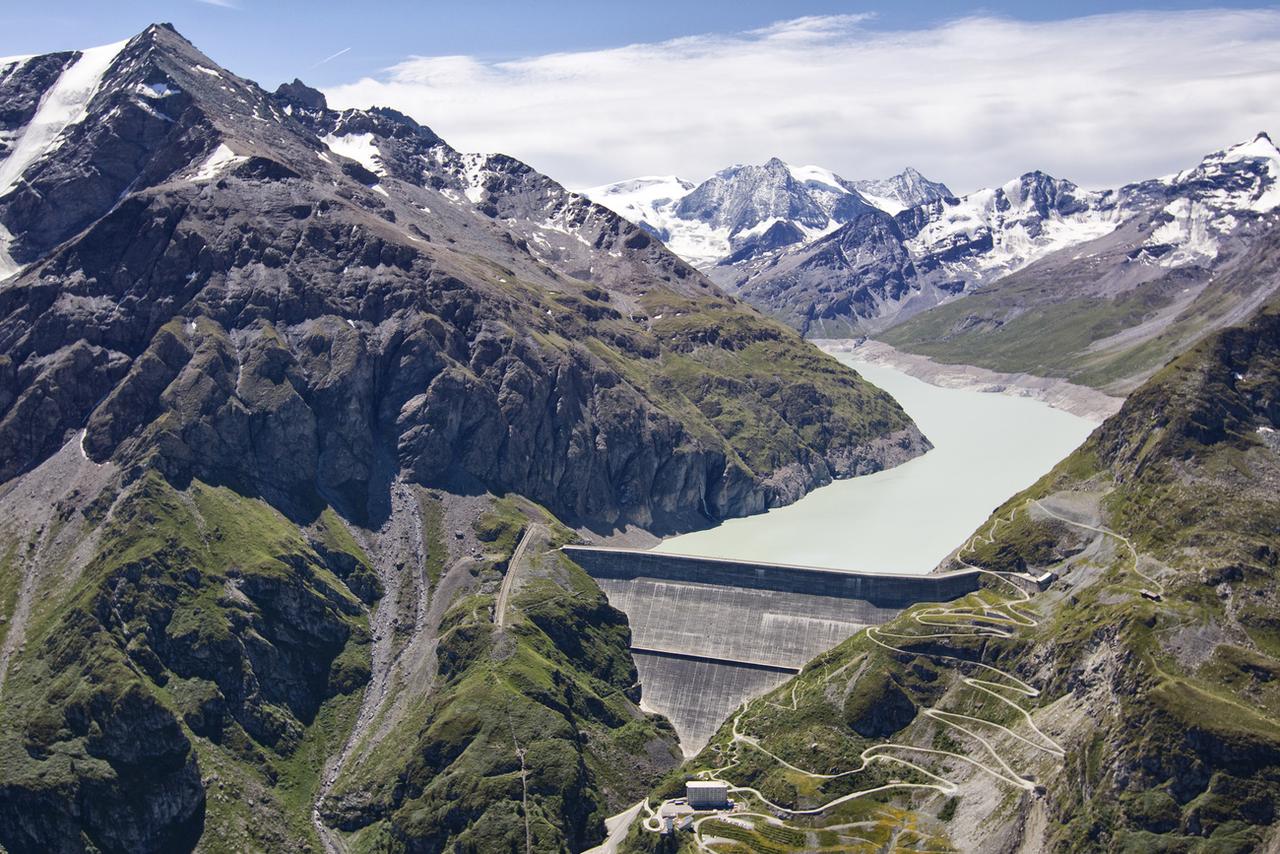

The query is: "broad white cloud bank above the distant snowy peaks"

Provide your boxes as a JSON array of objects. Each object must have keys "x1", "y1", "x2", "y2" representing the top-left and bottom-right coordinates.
[{"x1": 326, "y1": 9, "x2": 1280, "y2": 191}]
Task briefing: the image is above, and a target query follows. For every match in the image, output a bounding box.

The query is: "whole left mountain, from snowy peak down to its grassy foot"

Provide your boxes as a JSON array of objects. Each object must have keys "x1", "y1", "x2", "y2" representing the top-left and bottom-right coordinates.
[{"x1": 0, "y1": 26, "x2": 928, "y2": 851}]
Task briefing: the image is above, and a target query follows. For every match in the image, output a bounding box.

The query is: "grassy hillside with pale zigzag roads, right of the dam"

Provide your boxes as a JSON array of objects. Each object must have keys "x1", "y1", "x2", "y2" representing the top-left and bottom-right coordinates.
[{"x1": 627, "y1": 295, "x2": 1280, "y2": 853}]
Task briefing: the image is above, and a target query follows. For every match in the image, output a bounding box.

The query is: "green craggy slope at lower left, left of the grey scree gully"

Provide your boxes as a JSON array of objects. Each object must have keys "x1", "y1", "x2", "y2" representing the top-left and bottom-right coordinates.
[{"x1": 0, "y1": 474, "x2": 369, "y2": 851}]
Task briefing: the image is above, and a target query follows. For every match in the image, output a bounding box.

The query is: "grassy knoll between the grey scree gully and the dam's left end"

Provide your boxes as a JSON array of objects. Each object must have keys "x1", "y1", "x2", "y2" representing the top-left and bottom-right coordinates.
[{"x1": 321, "y1": 499, "x2": 678, "y2": 851}]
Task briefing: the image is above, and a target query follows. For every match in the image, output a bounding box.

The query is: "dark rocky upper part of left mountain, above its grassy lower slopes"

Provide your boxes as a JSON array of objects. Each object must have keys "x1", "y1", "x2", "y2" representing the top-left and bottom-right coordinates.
[{"x1": 0, "y1": 28, "x2": 913, "y2": 535}]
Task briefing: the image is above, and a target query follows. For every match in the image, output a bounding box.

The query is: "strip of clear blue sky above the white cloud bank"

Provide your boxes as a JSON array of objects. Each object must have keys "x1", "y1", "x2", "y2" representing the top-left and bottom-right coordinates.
[{"x1": 0, "y1": 0, "x2": 1275, "y2": 88}]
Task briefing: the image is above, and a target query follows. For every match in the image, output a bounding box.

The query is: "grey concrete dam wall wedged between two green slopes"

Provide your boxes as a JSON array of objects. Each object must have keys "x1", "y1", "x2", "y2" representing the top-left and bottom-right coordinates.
[{"x1": 563, "y1": 545, "x2": 980, "y2": 755}]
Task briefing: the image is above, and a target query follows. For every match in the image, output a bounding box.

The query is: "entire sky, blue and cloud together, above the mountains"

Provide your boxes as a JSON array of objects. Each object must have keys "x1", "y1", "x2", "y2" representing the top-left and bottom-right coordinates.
[{"x1": 0, "y1": 0, "x2": 1280, "y2": 192}]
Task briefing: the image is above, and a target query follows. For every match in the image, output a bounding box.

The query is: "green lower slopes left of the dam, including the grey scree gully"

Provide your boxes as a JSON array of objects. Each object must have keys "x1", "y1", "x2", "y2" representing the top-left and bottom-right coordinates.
[{"x1": 0, "y1": 458, "x2": 678, "y2": 853}]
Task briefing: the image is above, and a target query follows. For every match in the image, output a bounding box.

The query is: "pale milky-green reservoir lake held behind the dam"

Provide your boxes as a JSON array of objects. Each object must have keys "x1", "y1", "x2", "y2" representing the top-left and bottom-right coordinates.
[{"x1": 654, "y1": 355, "x2": 1097, "y2": 572}]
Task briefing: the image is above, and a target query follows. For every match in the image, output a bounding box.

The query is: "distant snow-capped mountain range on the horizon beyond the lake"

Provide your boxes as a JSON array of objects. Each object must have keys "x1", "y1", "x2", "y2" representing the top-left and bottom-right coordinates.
[{"x1": 589, "y1": 133, "x2": 1280, "y2": 338}]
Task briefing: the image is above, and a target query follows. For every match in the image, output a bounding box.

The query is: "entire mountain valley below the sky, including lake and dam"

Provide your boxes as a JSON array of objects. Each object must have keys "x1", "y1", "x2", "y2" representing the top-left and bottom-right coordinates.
[{"x1": 0, "y1": 15, "x2": 1280, "y2": 854}]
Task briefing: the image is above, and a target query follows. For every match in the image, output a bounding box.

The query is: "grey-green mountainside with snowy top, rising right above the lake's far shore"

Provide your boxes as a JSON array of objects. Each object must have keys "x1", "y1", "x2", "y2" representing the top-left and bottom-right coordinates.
[{"x1": 877, "y1": 134, "x2": 1280, "y2": 394}]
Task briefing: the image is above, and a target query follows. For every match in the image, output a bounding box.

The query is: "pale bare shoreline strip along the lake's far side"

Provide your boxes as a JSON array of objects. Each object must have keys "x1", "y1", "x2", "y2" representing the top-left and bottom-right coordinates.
[{"x1": 812, "y1": 338, "x2": 1124, "y2": 424}]
